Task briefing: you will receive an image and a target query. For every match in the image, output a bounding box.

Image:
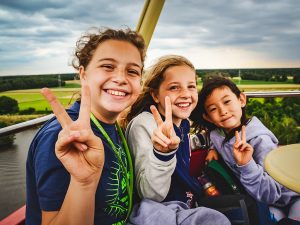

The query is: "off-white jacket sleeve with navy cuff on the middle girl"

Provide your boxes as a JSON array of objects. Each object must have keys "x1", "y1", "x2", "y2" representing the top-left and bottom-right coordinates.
[{"x1": 126, "y1": 112, "x2": 176, "y2": 202}]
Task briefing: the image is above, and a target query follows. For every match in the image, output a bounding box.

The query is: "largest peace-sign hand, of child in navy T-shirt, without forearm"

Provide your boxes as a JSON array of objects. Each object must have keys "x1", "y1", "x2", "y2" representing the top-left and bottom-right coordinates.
[{"x1": 42, "y1": 81, "x2": 104, "y2": 184}]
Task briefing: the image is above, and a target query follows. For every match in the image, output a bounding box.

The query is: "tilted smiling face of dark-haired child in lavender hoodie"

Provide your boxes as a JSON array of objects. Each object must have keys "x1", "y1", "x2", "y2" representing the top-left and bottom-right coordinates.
[{"x1": 203, "y1": 86, "x2": 246, "y2": 133}]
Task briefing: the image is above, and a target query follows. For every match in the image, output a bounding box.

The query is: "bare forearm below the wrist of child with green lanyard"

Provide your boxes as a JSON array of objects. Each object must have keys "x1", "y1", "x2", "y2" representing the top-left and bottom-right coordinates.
[{"x1": 42, "y1": 177, "x2": 98, "y2": 225}]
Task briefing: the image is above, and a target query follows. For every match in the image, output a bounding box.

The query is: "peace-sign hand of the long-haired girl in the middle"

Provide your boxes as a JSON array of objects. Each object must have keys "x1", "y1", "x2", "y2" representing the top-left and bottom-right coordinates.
[{"x1": 150, "y1": 96, "x2": 180, "y2": 152}]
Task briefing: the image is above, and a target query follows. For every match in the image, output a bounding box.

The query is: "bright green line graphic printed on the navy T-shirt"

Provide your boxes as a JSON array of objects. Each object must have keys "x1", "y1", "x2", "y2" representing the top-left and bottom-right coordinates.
[{"x1": 104, "y1": 146, "x2": 129, "y2": 220}]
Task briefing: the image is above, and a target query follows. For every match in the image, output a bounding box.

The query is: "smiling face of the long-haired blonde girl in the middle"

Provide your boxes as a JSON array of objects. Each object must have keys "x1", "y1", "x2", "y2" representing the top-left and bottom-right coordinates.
[{"x1": 151, "y1": 65, "x2": 198, "y2": 126}]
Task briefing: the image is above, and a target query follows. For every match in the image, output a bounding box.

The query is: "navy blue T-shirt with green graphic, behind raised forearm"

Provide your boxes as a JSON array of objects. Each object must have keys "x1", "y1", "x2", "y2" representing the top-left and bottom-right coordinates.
[{"x1": 26, "y1": 102, "x2": 129, "y2": 225}]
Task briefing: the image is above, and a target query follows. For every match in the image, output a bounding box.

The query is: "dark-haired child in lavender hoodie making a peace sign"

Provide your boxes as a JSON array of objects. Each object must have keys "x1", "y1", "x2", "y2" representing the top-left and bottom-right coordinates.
[{"x1": 191, "y1": 77, "x2": 300, "y2": 220}]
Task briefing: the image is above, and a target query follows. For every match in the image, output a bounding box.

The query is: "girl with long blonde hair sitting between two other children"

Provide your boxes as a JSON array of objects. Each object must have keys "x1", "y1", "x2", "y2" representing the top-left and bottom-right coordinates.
[{"x1": 126, "y1": 55, "x2": 229, "y2": 224}]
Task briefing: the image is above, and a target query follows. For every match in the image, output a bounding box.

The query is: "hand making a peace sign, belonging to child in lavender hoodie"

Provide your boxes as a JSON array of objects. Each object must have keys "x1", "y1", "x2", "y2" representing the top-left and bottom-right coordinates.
[{"x1": 233, "y1": 126, "x2": 254, "y2": 166}]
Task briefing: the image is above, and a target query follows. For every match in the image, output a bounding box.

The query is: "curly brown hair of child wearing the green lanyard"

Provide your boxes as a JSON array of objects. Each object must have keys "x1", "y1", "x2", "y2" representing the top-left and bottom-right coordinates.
[{"x1": 72, "y1": 28, "x2": 146, "y2": 70}]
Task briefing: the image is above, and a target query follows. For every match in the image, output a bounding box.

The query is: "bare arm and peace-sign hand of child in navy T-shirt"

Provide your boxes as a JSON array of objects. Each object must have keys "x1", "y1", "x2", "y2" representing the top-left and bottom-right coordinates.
[{"x1": 42, "y1": 83, "x2": 104, "y2": 225}]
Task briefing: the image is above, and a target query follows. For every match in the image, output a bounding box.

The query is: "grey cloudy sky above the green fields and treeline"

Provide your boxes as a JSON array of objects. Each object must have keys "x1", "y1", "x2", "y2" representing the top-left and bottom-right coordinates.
[{"x1": 0, "y1": 0, "x2": 300, "y2": 76}]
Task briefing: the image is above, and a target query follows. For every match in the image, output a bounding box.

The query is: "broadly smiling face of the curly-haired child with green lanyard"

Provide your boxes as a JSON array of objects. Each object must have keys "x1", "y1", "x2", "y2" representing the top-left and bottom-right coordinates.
[{"x1": 79, "y1": 40, "x2": 143, "y2": 123}]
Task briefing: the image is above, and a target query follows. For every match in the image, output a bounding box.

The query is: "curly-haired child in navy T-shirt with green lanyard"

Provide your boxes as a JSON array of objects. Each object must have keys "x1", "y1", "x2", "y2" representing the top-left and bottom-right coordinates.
[{"x1": 26, "y1": 26, "x2": 145, "y2": 225}]
